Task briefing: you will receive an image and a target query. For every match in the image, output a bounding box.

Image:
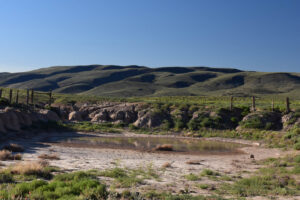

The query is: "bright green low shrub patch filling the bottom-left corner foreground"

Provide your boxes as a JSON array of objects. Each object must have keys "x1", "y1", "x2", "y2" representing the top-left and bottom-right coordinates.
[{"x1": 0, "y1": 172, "x2": 108, "y2": 199}]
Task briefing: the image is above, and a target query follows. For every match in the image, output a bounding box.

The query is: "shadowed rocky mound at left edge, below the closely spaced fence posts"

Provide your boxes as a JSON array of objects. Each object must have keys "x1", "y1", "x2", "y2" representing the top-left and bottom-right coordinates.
[{"x1": 0, "y1": 107, "x2": 60, "y2": 133}]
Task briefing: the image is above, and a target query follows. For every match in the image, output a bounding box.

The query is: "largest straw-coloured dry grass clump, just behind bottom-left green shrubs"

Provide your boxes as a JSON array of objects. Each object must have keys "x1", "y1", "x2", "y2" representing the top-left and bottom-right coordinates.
[{"x1": 11, "y1": 162, "x2": 44, "y2": 175}]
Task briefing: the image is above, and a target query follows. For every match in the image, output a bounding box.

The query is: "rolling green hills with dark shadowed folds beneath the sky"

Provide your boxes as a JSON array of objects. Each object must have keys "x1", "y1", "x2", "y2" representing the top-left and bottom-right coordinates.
[{"x1": 0, "y1": 65, "x2": 300, "y2": 97}]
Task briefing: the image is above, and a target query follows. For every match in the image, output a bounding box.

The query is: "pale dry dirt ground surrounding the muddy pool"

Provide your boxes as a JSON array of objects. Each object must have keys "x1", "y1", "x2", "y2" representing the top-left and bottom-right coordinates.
[{"x1": 2, "y1": 133, "x2": 295, "y2": 200}]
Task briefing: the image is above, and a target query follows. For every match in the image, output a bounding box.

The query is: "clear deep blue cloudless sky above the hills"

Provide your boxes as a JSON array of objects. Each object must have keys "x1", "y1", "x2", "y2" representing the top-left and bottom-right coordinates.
[{"x1": 0, "y1": 0, "x2": 300, "y2": 72}]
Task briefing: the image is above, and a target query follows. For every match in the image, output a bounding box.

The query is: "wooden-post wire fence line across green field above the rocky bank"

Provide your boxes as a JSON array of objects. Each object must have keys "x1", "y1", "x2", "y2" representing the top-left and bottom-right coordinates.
[{"x1": 0, "y1": 88, "x2": 300, "y2": 112}]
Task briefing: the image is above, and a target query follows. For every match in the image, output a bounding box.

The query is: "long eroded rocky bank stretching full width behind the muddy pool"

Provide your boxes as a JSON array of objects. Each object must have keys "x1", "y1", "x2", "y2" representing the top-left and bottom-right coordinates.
[{"x1": 0, "y1": 102, "x2": 300, "y2": 132}]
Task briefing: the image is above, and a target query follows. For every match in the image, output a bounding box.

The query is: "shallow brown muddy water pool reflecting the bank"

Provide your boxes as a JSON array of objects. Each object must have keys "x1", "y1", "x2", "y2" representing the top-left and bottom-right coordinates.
[{"x1": 51, "y1": 136, "x2": 245, "y2": 154}]
